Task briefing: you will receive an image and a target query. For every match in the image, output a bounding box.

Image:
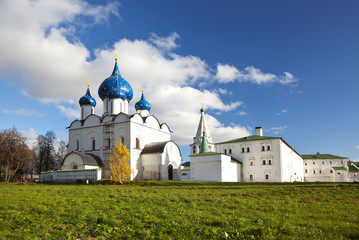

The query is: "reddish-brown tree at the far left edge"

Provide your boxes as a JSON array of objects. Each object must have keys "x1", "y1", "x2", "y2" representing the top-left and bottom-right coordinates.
[{"x1": 0, "y1": 127, "x2": 34, "y2": 182}]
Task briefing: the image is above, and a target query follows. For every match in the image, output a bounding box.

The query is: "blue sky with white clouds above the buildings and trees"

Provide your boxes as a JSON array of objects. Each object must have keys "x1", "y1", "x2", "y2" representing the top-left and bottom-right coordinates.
[{"x1": 0, "y1": 0, "x2": 359, "y2": 161}]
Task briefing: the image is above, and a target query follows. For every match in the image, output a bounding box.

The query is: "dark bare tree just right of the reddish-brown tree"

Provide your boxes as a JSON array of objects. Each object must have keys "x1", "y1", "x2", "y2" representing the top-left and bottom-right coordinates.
[{"x1": 35, "y1": 131, "x2": 57, "y2": 173}]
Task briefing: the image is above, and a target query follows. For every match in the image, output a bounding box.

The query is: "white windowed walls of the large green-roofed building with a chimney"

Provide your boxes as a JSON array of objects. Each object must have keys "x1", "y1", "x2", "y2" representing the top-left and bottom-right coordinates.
[{"x1": 217, "y1": 135, "x2": 304, "y2": 182}]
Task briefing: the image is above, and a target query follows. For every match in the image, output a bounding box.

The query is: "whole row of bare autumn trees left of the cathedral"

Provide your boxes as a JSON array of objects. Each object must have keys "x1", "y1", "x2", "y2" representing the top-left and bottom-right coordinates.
[{"x1": 0, "y1": 127, "x2": 67, "y2": 182}]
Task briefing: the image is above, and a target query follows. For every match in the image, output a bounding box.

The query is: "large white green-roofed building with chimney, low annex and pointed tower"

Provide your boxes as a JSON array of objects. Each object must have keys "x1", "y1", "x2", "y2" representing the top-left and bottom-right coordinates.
[{"x1": 190, "y1": 110, "x2": 304, "y2": 182}]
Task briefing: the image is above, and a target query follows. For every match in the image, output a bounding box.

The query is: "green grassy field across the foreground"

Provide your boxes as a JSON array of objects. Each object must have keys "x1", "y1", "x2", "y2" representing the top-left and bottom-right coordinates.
[{"x1": 0, "y1": 182, "x2": 359, "y2": 239}]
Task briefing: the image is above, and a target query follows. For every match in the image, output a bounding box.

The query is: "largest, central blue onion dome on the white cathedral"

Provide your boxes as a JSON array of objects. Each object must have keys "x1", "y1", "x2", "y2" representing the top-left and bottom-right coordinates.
[{"x1": 98, "y1": 61, "x2": 133, "y2": 101}]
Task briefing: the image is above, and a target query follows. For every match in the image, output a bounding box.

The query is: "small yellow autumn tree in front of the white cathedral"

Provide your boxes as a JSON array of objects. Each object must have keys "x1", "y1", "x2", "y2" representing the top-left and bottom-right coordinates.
[{"x1": 106, "y1": 141, "x2": 131, "y2": 183}]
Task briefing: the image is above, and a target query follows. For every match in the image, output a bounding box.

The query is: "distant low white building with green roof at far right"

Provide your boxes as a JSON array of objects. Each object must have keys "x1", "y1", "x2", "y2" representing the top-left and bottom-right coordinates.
[{"x1": 302, "y1": 152, "x2": 349, "y2": 182}]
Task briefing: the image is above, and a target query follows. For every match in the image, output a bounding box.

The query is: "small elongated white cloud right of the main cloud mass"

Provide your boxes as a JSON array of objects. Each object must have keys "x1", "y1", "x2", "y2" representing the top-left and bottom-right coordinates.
[{"x1": 215, "y1": 64, "x2": 297, "y2": 85}]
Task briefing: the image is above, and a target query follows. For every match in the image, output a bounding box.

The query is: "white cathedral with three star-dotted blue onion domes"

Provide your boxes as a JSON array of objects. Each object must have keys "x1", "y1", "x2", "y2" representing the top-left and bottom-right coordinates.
[{"x1": 62, "y1": 55, "x2": 182, "y2": 180}]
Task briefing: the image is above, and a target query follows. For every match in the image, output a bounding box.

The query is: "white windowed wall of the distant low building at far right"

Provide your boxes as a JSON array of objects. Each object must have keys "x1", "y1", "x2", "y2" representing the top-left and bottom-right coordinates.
[{"x1": 304, "y1": 159, "x2": 349, "y2": 182}]
